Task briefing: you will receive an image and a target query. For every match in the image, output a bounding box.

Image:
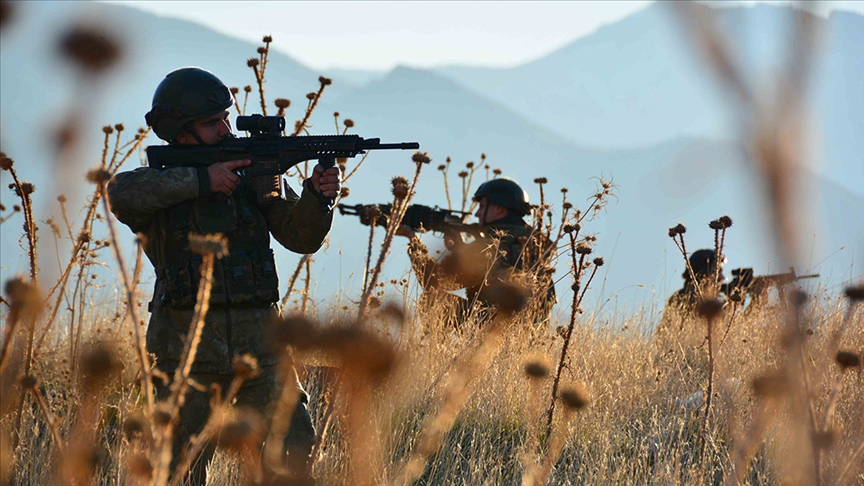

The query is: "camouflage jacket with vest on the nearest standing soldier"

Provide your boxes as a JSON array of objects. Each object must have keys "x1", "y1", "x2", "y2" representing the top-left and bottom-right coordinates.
[{"x1": 108, "y1": 167, "x2": 333, "y2": 373}]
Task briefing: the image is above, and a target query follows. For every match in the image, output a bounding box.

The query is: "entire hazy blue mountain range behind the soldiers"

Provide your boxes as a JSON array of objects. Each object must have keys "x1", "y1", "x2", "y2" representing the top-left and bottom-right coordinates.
[{"x1": 0, "y1": 2, "x2": 864, "y2": 316}]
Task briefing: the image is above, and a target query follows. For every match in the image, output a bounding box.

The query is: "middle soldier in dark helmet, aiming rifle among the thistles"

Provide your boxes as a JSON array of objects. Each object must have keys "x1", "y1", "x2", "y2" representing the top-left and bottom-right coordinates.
[{"x1": 396, "y1": 178, "x2": 556, "y2": 322}]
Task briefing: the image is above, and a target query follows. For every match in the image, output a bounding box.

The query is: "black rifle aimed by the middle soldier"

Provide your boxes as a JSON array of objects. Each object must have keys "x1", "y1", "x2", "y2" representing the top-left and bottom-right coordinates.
[{"x1": 338, "y1": 204, "x2": 481, "y2": 235}]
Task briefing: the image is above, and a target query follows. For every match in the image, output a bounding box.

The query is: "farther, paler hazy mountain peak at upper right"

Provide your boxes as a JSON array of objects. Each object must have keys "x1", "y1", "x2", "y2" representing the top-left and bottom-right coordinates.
[{"x1": 436, "y1": 2, "x2": 864, "y2": 195}]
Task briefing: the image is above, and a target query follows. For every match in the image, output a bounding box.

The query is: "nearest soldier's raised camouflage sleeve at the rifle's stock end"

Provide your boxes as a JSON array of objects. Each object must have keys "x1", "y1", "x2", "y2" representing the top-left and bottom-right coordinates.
[{"x1": 107, "y1": 167, "x2": 204, "y2": 232}]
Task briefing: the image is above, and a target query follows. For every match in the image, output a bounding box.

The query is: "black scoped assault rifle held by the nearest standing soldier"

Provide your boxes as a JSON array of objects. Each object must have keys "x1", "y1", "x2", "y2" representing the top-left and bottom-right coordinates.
[{"x1": 147, "y1": 115, "x2": 420, "y2": 210}]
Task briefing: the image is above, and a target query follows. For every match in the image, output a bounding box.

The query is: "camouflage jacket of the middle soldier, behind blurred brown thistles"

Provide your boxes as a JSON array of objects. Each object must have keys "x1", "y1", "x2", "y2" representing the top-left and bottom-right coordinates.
[{"x1": 408, "y1": 216, "x2": 557, "y2": 318}]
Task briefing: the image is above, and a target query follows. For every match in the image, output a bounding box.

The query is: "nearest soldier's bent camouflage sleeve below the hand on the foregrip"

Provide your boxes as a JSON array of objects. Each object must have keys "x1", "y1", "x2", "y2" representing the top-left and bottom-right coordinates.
[{"x1": 262, "y1": 178, "x2": 333, "y2": 254}]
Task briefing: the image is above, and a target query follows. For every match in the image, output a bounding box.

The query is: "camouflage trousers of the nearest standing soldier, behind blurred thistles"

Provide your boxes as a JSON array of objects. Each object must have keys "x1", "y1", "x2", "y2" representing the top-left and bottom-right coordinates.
[{"x1": 156, "y1": 366, "x2": 315, "y2": 486}]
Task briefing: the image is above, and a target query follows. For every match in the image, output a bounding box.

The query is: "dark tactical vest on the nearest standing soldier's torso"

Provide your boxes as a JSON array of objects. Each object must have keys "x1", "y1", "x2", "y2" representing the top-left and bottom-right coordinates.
[{"x1": 154, "y1": 179, "x2": 279, "y2": 309}]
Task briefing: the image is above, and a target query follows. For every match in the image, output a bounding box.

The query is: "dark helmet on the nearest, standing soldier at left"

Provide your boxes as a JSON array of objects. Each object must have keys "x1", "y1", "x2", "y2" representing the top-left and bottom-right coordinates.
[{"x1": 144, "y1": 67, "x2": 234, "y2": 142}]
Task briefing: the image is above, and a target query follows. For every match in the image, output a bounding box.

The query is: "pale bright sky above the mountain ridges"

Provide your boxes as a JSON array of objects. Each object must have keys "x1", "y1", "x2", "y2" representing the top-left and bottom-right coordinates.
[{"x1": 109, "y1": 0, "x2": 864, "y2": 70}]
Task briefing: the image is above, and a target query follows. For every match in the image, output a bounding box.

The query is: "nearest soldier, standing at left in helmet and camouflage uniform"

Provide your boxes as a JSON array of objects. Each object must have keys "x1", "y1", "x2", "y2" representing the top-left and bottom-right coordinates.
[{"x1": 108, "y1": 67, "x2": 341, "y2": 485}]
